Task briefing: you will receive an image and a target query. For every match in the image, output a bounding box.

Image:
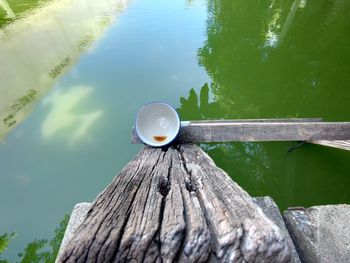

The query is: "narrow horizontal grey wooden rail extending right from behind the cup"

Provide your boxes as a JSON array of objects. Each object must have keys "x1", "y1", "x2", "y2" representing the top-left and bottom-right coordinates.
[{"x1": 132, "y1": 119, "x2": 350, "y2": 143}]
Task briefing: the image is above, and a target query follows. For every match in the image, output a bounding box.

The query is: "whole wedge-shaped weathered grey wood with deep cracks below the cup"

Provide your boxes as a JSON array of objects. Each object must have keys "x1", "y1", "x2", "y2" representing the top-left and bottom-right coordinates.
[{"x1": 58, "y1": 145, "x2": 291, "y2": 262}]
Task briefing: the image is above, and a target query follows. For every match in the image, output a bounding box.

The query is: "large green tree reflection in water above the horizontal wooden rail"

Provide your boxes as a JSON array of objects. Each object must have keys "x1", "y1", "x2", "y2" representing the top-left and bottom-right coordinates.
[{"x1": 198, "y1": 0, "x2": 350, "y2": 121}]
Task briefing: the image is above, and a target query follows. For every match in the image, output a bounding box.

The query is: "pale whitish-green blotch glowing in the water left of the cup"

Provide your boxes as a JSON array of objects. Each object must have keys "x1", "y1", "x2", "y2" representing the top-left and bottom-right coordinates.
[{"x1": 41, "y1": 85, "x2": 103, "y2": 144}]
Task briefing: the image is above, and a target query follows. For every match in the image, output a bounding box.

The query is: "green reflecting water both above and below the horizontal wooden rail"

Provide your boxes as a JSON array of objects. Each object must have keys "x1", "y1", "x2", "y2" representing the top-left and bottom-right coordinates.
[{"x1": 194, "y1": 0, "x2": 350, "y2": 209}]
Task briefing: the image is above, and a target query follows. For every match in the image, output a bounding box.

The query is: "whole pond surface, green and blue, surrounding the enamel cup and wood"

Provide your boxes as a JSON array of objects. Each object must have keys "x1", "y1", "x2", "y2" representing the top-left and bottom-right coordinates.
[{"x1": 0, "y1": 0, "x2": 350, "y2": 260}]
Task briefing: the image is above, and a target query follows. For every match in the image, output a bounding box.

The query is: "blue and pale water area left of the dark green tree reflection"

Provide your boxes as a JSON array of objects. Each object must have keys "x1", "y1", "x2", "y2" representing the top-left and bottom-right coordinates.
[{"x1": 0, "y1": 0, "x2": 209, "y2": 259}]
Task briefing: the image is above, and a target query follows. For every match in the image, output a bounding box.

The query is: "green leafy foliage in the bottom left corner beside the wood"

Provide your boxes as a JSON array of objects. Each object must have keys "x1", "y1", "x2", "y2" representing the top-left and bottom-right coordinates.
[{"x1": 0, "y1": 215, "x2": 69, "y2": 263}]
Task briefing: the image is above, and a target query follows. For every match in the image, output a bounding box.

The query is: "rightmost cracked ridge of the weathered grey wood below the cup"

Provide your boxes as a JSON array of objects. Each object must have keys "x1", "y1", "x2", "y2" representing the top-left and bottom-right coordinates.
[{"x1": 181, "y1": 145, "x2": 291, "y2": 262}]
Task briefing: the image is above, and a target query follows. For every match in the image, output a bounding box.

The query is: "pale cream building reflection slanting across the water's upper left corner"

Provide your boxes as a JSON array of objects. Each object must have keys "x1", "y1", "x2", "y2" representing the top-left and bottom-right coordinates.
[{"x1": 0, "y1": 0, "x2": 128, "y2": 142}]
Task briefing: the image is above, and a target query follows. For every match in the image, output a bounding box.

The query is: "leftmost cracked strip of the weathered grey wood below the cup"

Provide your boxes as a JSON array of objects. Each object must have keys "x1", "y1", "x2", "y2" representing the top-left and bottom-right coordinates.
[{"x1": 58, "y1": 148, "x2": 160, "y2": 262}]
